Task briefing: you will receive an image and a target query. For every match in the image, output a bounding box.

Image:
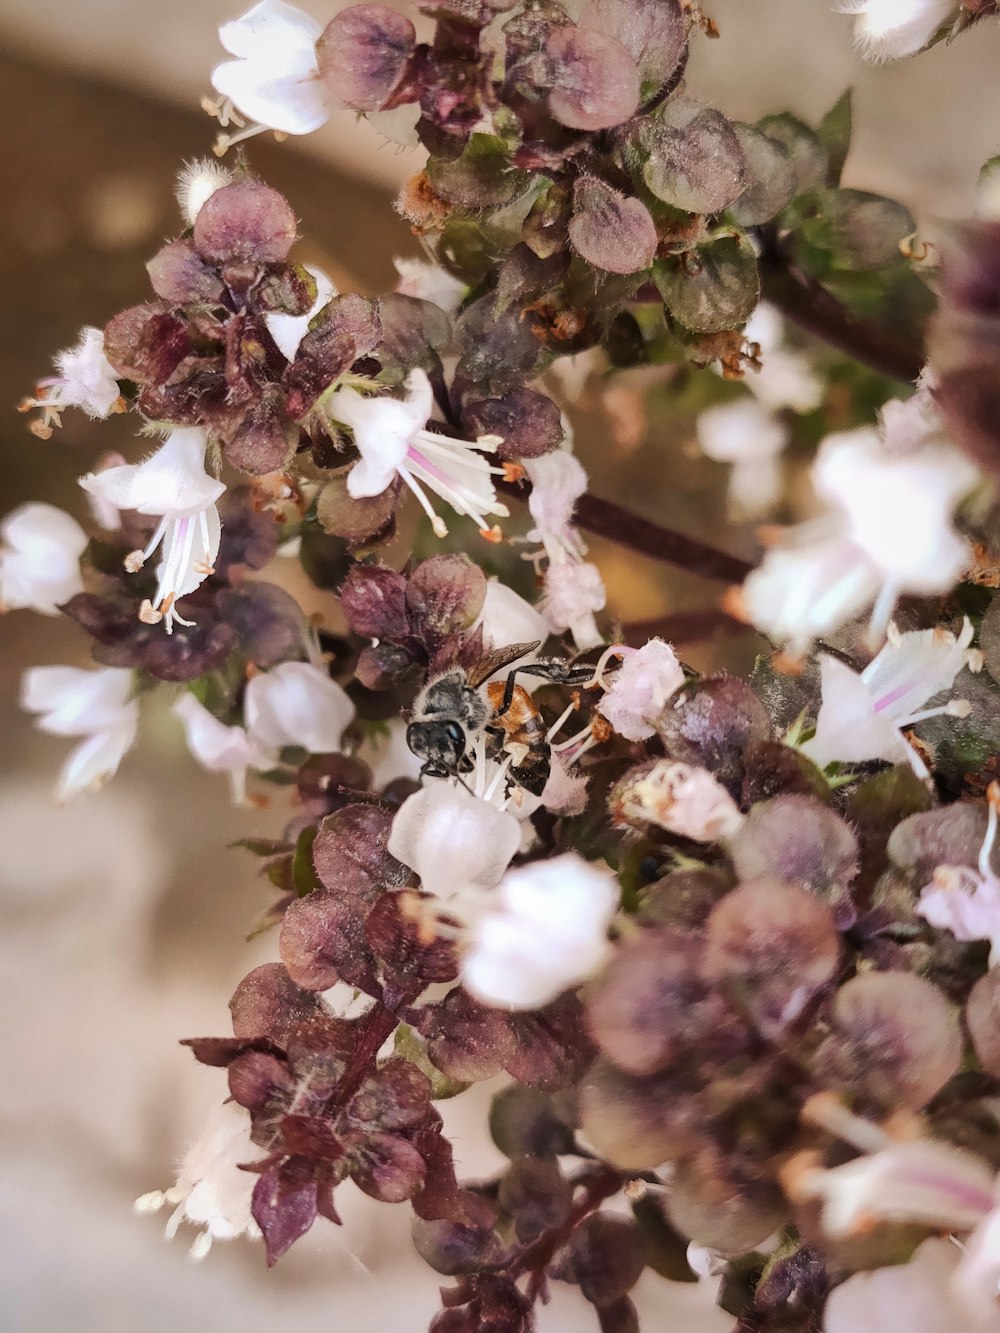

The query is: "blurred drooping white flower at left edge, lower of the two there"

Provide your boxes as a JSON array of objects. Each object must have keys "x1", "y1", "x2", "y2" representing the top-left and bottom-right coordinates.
[{"x1": 20, "y1": 667, "x2": 139, "y2": 801}]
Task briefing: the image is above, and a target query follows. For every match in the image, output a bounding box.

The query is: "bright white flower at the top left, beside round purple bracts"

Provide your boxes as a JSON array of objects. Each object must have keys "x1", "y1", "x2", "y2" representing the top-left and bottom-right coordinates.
[{"x1": 212, "y1": 0, "x2": 328, "y2": 142}]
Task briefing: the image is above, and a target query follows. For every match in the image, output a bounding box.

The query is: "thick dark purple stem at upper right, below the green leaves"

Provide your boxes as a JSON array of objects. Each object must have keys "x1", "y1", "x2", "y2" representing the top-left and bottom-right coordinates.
[{"x1": 757, "y1": 232, "x2": 924, "y2": 384}]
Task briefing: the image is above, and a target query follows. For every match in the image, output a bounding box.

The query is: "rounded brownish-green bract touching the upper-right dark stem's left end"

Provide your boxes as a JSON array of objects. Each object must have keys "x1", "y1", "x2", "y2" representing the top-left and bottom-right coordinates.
[{"x1": 653, "y1": 236, "x2": 760, "y2": 333}]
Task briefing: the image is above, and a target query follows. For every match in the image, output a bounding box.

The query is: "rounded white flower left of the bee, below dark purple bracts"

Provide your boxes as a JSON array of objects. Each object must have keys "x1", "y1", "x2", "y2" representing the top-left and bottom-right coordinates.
[{"x1": 243, "y1": 663, "x2": 355, "y2": 754}]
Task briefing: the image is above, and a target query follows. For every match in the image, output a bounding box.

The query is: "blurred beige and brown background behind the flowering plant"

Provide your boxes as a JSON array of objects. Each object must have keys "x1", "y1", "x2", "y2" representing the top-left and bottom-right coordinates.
[{"x1": 0, "y1": 0, "x2": 1000, "y2": 1333}]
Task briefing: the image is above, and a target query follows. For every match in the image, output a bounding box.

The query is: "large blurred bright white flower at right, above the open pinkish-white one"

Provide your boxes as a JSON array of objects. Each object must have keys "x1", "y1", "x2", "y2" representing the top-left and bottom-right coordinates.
[{"x1": 729, "y1": 383, "x2": 979, "y2": 653}]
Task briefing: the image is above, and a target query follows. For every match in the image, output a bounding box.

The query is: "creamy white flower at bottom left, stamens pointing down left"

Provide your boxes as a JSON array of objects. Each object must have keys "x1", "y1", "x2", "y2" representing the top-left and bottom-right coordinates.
[{"x1": 135, "y1": 1101, "x2": 260, "y2": 1260}]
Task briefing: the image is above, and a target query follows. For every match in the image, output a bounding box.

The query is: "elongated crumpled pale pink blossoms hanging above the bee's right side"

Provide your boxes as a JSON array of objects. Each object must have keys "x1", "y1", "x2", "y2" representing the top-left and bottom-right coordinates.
[{"x1": 524, "y1": 449, "x2": 607, "y2": 652}]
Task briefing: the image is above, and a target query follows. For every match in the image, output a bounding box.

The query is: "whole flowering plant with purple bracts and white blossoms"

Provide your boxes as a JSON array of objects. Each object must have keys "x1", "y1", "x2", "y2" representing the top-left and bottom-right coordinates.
[{"x1": 13, "y1": 0, "x2": 1000, "y2": 1333}]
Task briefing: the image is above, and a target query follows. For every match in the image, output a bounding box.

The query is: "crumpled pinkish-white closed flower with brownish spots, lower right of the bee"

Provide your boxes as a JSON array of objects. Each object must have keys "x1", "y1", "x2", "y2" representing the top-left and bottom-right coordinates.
[{"x1": 609, "y1": 758, "x2": 743, "y2": 842}]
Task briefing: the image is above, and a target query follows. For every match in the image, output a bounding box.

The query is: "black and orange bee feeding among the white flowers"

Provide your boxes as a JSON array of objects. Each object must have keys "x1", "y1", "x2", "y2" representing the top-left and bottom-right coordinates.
[{"x1": 407, "y1": 641, "x2": 593, "y2": 796}]
